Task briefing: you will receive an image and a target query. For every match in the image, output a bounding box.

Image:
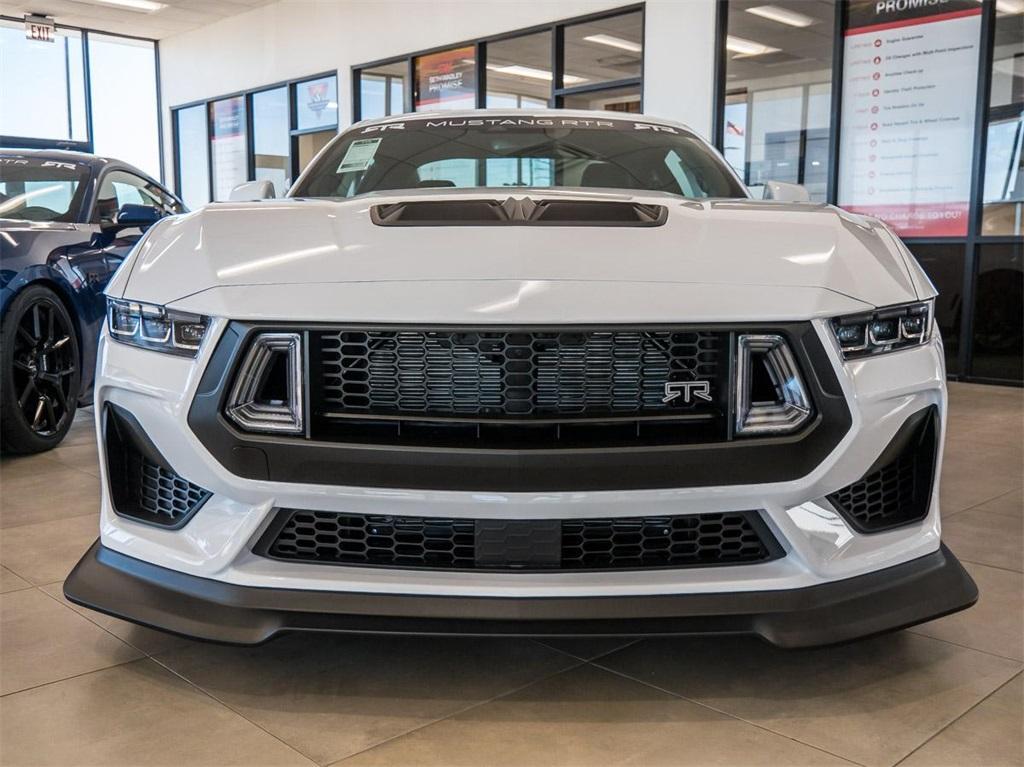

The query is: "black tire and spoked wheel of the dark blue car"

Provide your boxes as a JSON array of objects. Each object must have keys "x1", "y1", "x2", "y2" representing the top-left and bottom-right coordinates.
[{"x1": 0, "y1": 286, "x2": 81, "y2": 454}]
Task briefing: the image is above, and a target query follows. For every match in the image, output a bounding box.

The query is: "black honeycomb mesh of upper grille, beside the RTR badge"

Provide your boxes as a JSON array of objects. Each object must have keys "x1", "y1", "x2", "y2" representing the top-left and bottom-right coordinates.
[{"x1": 312, "y1": 330, "x2": 725, "y2": 418}]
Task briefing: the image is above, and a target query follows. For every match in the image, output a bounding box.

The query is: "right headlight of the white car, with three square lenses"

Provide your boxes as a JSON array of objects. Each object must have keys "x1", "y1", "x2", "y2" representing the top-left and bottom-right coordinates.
[{"x1": 831, "y1": 301, "x2": 935, "y2": 359}]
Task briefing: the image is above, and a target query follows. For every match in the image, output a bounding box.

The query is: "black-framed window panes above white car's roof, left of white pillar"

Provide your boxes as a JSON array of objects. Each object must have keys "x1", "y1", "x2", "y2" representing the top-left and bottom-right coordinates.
[{"x1": 352, "y1": 6, "x2": 644, "y2": 120}]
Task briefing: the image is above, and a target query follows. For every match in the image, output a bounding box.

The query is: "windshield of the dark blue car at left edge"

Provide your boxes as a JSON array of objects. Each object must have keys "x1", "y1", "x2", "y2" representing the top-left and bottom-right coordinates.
[{"x1": 0, "y1": 157, "x2": 89, "y2": 223}]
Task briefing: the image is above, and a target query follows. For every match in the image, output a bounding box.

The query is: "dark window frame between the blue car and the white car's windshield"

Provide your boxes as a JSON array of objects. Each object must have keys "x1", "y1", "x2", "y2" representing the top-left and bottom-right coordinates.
[{"x1": 170, "y1": 70, "x2": 340, "y2": 202}]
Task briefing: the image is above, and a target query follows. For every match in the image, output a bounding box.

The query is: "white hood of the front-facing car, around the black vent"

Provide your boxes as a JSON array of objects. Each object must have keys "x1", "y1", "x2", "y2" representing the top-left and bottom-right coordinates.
[{"x1": 114, "y1": 189, "x2": 921, "y2": 308}]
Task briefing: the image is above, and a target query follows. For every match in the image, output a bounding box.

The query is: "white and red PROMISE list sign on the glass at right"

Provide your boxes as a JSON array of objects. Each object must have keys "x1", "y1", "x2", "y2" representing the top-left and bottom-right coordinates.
[{"x1": 839, "y1": 0, "x2": 981, "y2": 237}]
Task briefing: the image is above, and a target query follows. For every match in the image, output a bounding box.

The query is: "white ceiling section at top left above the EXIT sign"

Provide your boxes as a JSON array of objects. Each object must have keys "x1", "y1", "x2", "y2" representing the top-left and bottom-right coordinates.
[{"x1": 2, "y1": 0, "x2": 274, "y2": 40}]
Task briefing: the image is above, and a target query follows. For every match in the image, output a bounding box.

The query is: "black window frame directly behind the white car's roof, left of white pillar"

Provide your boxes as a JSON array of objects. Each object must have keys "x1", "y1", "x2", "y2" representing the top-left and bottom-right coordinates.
[{"x1": 351, "y1": 3, "x2": 647, "y2": 123}]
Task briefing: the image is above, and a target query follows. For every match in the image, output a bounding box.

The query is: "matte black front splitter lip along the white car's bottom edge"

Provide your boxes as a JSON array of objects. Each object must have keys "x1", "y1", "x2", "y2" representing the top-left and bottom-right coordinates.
[{"x1": 65, "y1": 541, "x2": 978, "y2": 647}]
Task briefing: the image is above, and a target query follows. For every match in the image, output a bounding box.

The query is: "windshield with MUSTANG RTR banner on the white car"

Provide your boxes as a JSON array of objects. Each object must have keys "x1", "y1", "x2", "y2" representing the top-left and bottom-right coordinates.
[{"x1": 292, "y1": 116, "x2": 746, "y2": 198}]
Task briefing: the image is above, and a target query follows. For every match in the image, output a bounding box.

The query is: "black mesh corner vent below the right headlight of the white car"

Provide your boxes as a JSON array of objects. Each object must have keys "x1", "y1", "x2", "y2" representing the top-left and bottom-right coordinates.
[{"x1": 828, "y1": 408, "x2": 938, "y2": 532}]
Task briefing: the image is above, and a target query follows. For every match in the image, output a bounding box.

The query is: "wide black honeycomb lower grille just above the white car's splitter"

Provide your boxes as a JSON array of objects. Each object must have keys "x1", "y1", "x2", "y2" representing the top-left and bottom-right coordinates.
[{"x1": 255, "y1": 509, "x2": 781, "y2": 570}]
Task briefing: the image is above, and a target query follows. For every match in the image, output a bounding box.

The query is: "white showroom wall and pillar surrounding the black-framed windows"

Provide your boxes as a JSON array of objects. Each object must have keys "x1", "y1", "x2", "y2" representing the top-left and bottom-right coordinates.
[{"x1": 160, "y1": 0, "x2": 715, "y2": 183}]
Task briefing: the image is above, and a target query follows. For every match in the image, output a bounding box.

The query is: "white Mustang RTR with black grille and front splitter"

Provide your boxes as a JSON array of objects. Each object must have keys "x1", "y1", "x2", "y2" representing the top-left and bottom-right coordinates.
[{"x1": 65, "y1": 111, "x2": 977, "y2": 646}]
